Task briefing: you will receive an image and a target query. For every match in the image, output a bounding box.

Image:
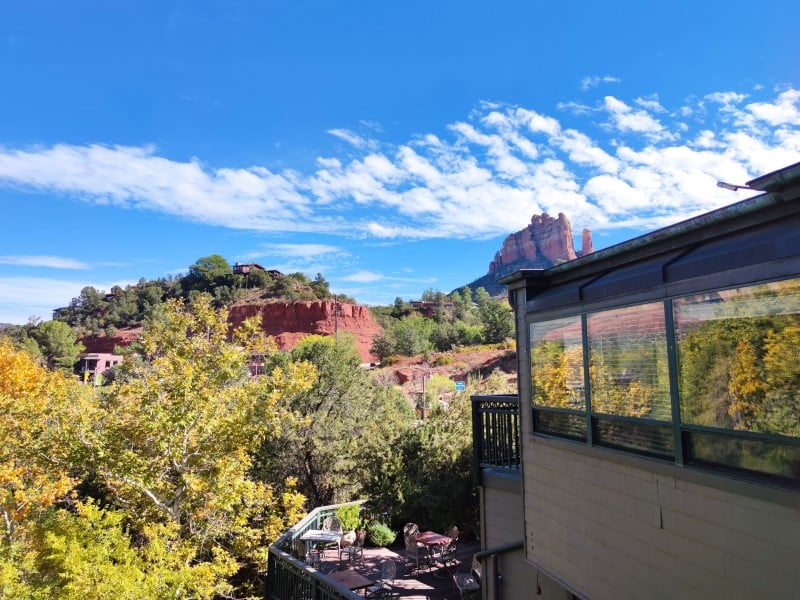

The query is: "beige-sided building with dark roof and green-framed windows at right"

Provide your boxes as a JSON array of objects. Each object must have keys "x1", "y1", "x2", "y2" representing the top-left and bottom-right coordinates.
[{"x1": 473, "y1": 163, "x2": 800, "y2": 600}]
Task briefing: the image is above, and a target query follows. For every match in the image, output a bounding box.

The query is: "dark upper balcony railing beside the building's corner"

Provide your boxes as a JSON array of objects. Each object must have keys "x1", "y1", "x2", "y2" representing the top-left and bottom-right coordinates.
[{"x1": 471, "y1": 394, "x2": 520, "y2": 485}]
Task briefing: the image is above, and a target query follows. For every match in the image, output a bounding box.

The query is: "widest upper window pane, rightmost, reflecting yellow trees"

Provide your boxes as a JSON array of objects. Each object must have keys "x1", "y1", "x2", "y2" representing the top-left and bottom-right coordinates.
[{"x1": 673, "y1": 279, "x2": 800, "y2": 437}]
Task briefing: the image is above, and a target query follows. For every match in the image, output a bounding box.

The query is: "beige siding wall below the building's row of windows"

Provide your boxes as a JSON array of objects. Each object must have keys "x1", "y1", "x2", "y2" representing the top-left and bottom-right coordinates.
[{"x1": 524, "y1": 438, "x2": 800, "y2": 600}]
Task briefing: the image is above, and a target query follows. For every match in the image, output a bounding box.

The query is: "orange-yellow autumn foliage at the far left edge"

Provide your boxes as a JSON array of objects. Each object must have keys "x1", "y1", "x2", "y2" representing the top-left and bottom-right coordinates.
[{"x1": 0, "y1": 338, "x2": 92, "y2": 598}]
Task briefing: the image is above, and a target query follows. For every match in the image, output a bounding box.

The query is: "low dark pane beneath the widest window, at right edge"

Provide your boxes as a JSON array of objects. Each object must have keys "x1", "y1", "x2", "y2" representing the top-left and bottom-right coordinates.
[{"x1": 686, "y1": 431, "x2": 800, "y2": 481}]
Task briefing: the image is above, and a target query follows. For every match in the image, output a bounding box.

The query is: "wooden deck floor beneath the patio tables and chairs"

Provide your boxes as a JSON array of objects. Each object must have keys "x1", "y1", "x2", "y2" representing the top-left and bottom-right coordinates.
[{"x1": 312, "y1": 542, "x2": 480, "y2": 600}]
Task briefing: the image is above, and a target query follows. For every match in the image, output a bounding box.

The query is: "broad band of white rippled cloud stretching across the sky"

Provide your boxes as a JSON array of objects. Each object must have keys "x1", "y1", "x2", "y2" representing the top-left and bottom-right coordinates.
[{"x1": 0, "y1": 86, "x2": 800, "y2": 244}]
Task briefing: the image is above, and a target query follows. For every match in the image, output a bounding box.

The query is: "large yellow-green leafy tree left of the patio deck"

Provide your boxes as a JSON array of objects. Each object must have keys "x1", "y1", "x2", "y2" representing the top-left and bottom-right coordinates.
[{"x1": 81, "y1": 295, "x2": 317, "y2": 596}]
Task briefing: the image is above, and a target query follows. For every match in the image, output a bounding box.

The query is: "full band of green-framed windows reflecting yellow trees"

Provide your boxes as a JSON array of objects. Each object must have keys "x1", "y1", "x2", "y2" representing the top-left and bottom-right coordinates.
[{"x1": 530, "y1": 279, "x2": 800, "y2": 486}]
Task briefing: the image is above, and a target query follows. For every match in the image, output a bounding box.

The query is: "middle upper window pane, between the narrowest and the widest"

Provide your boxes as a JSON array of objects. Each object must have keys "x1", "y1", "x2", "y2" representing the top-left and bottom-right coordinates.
[{"x1": 588, "y1": 303, "x2": 672, "y2": 421}]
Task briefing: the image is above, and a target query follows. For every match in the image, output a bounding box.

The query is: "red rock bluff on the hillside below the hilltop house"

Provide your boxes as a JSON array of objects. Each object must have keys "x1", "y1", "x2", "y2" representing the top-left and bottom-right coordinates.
[{"x1": 228, "y1": 301, "x2": 381, "y2": 363}]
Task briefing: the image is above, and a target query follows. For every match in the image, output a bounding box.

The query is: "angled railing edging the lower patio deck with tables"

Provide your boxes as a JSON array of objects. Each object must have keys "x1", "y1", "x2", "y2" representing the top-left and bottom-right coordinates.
[{"x1": 264, "y1": 502, "x2": 363, "y2": 600}]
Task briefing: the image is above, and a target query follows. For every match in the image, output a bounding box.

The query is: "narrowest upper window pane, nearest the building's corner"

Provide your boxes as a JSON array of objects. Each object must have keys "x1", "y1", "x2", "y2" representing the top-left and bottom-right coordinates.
[{"x1": 531, "y1": 316, "x2": 586, "y2": 410}]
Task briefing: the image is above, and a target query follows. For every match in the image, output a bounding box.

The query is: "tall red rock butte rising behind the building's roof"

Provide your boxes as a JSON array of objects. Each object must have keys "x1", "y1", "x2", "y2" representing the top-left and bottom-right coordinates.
[{"x1": 489, "y1": 213, "x2": 593, "y2": 273}]
